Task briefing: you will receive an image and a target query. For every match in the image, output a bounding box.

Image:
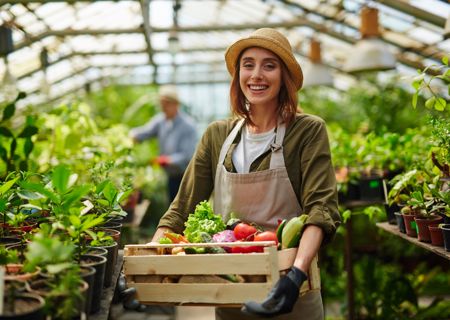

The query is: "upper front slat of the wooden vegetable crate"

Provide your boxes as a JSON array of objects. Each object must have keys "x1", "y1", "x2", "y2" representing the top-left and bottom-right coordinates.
[{"x1": 124, "y1": 253, "x2": 271, "y2": 275}]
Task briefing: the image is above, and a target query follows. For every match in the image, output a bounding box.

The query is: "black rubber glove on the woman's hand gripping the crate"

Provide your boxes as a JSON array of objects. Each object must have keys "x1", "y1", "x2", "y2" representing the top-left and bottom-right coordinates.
[{"x1": 241, "y1": 267, "x2": 308, "y2": 317}]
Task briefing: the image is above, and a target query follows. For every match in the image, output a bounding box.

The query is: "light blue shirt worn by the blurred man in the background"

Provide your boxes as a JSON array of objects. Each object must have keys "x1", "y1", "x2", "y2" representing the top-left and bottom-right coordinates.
[{"x1": 130, "y1": 111, "x2": 197, "y2": 176}]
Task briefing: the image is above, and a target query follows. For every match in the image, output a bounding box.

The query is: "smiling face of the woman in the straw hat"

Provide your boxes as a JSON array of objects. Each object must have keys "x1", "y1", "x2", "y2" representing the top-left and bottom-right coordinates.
[{"x1": 239, "y1": 47, "x2": 282, "y2": 109}]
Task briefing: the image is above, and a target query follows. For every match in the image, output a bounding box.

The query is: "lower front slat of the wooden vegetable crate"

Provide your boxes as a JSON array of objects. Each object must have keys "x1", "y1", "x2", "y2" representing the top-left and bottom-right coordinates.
[{"x1": 130, "y1": 283, "x2": 271, "y2": 305}]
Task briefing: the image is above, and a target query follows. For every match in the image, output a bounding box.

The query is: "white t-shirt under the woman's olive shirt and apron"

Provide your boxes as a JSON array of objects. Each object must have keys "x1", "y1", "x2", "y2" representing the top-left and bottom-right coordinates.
[{"x1": 232, "y1": 126, "x2": 275, "y2": 173}]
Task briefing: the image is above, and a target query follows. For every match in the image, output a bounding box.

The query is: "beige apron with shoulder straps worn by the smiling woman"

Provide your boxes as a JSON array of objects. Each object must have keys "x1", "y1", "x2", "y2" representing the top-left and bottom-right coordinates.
[{"x1": 214, "y1": 120, "x2": 323, "y2": 320}]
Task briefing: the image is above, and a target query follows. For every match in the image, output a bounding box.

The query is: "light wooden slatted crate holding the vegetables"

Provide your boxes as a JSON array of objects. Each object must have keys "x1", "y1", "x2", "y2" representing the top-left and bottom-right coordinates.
[{"x1": 124, "y1": 241, "x2": 297, "y2": 306}]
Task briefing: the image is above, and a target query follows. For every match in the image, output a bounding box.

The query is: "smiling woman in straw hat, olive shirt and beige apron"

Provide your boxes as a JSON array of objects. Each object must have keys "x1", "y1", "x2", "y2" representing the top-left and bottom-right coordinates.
[{"x1": 153, "y1": 28, "x2": 340, "y2": 320}]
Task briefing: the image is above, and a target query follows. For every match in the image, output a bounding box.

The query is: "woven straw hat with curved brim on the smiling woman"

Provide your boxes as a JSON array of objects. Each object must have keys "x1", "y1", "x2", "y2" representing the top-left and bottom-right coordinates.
[{"x1": 225, "y1": 28, "x2": 303, "y2": 90}]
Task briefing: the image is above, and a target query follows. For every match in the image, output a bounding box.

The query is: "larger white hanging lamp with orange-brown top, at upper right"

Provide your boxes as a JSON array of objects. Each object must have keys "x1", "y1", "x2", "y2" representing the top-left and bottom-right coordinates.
[{"x1": 343, "y1": 7, "x2": 396, "y2": 73}]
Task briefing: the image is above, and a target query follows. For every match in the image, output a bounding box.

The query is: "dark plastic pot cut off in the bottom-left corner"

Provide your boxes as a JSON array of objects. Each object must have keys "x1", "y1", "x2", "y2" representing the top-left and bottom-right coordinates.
[{"x1": 0, "y1": 293, "x2": 45, "y2": 320}]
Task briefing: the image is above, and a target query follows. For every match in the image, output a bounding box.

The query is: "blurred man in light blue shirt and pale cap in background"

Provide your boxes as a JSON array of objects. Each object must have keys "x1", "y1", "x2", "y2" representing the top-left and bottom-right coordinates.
[{"x1": 130, "y1": 85, "x2": 197, "y2": 202}]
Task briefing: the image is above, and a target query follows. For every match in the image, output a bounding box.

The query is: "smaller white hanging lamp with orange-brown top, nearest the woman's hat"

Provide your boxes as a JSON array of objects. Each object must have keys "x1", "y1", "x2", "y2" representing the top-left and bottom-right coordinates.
[{"x1": 303, "y1": 38, "x2": 333, "y2": 87}]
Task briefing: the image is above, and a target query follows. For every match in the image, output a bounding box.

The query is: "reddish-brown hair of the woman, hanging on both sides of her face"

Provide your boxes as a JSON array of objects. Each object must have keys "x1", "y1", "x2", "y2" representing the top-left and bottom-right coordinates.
[{"x1": 230, "y1": 48, "x2": 300, "y2": 125}]
